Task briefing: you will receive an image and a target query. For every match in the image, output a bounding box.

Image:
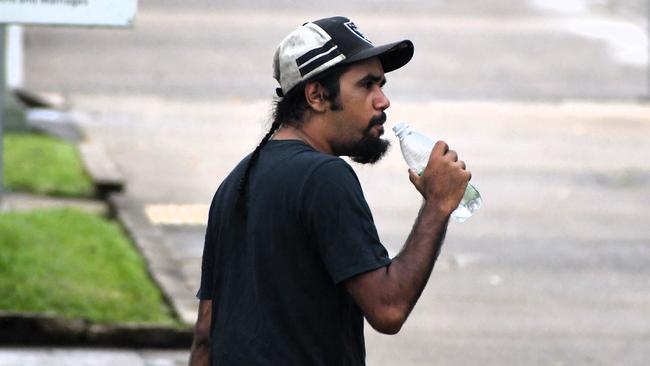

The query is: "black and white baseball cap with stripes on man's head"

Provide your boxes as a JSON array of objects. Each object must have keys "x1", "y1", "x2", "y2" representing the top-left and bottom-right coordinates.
[{"x1": 273, "y1": 16, "x2": 414, "y2": 96}]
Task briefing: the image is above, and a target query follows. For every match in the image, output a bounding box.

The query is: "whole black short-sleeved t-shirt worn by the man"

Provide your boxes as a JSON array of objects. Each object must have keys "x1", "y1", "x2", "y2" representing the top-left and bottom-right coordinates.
[{"x1": 197, "y1": 140, "x2": 390, "y2": 366}]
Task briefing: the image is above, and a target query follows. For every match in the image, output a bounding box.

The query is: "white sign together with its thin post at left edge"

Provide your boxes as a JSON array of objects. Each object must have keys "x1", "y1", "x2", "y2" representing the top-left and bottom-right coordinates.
[{"x1": 0, "y1": 0, "x2": 138, "y2": 205}]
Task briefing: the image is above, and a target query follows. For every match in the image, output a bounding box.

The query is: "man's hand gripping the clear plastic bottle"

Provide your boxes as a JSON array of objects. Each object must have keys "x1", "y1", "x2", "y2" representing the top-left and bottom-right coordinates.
[{"x1": 409, "y1": 141, "x2": 472, "y2": 213}]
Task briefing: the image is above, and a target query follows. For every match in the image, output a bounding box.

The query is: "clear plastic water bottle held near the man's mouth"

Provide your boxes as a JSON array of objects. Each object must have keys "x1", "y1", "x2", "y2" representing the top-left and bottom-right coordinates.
[{"x1": 393, "y1": 122, "x2": 482, "y2": 222}]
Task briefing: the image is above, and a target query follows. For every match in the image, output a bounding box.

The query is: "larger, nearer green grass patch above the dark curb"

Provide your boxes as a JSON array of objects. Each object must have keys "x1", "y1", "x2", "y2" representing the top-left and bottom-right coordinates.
[{"x1": 0, "y1": 209, "x2": 178, "y2": 325}]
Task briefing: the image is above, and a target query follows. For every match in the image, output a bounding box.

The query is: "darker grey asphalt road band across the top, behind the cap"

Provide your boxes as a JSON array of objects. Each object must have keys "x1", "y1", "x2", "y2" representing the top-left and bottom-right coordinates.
[{"x1": 26, "y1": 0, "x2": 650, "y2": 100}]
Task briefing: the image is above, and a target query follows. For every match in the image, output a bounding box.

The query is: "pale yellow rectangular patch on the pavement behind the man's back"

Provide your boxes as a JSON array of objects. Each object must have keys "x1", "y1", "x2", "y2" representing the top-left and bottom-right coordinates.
[{"x1": 145, "y1": 204, "x2": 210, "y2": 225}]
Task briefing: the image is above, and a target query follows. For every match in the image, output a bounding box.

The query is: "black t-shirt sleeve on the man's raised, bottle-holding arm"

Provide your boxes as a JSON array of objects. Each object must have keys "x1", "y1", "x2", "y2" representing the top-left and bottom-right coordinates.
[{"x1": 303, "y1": 159, "x2": 391, "y2": 284}]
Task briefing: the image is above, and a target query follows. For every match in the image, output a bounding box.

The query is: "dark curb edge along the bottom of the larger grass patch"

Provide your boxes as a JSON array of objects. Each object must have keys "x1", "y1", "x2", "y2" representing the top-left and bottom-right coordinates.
[{"x1": 0, "y1": 312, "x2": 193, "y2": 349}]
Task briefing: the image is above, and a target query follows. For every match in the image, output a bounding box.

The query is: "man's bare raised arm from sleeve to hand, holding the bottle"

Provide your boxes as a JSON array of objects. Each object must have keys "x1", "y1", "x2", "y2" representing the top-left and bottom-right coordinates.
[{"x1": 345, "y1": 141, "x2": 471, "y2": 334}]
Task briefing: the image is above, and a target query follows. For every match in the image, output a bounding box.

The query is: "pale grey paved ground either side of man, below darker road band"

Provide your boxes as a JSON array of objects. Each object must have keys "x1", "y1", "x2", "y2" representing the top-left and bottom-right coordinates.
[{"x1": 0, "y1": 96, "x2": 650, "y2": 365}]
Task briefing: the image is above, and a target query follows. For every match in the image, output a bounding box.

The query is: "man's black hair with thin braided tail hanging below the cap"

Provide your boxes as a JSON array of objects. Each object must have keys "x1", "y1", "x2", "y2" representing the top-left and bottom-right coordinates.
[{"x1": 239, "y1": 66, "x2": 347, "y2": 207}]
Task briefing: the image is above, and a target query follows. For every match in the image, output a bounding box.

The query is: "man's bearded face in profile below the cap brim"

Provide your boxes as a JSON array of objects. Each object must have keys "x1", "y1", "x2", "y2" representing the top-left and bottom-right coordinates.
[{"x1": 330, "y1": 58, "x2": 390, "y2": 164}]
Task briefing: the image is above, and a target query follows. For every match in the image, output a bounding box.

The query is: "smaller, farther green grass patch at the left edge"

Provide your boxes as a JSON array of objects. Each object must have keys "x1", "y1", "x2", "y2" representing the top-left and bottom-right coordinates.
[{"x1": 3, "y1": 133, "x2": 94, "y2": 197}]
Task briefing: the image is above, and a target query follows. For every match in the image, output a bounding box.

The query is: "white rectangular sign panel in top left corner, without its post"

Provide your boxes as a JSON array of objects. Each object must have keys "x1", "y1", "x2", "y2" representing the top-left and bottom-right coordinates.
[{"x1": 0, "y1": 0, "x2": 138, "y2": 26}]
